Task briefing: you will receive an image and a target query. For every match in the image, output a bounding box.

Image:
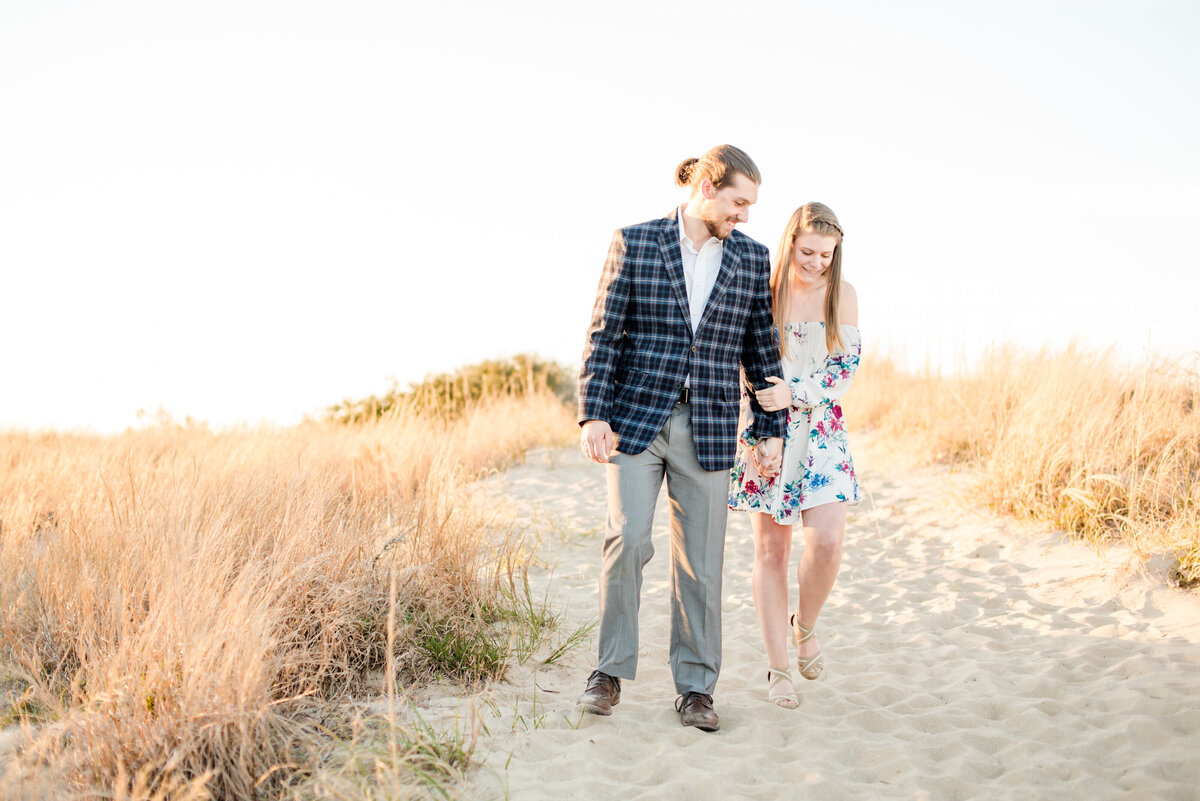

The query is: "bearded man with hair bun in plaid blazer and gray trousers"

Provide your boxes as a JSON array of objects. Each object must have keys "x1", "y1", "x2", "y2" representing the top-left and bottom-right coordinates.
[{"x1": 578, "y1": 145, "x2": 786, "y2": 731}]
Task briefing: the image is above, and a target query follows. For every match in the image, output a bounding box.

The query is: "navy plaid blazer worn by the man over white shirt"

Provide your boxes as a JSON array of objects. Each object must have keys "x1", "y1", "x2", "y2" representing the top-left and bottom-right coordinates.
[{"x1": 580, "y1": 210, "x2": 787, "y2": 470}]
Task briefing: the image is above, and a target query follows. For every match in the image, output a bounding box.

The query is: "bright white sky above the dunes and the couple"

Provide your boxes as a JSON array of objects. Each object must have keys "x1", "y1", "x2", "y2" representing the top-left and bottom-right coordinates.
[{"x1": 0, "y1": 0, "x2": 1200, "y2": 430}]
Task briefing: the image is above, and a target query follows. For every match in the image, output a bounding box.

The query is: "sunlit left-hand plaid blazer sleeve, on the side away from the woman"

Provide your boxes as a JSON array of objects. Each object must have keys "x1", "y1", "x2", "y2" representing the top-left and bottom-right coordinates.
[{"x1": 578, "y1": 230, "x2": 630, "y2": 426}]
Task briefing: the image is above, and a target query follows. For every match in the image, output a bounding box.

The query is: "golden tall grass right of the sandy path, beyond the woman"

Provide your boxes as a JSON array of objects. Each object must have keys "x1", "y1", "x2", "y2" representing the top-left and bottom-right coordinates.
[{"x1": 847, "y1": 345, "x2": 1200, "y2": 584}]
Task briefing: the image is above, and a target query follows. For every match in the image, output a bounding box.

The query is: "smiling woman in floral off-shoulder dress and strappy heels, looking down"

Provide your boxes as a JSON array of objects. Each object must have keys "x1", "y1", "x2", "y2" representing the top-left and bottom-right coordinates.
[{"x1": 730, "y1": 203, "x2": 862, "y2": 709}]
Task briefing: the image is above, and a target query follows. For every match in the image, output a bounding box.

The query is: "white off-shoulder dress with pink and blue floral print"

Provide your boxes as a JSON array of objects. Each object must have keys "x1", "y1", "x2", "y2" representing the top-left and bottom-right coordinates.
[{"x1": 730, "y1": 323, "x2": 863, "y2": 525}]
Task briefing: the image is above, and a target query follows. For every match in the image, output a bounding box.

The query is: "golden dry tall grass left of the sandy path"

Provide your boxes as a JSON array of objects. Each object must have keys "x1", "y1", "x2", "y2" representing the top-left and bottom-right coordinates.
[{"x1": 0, "y1": 393, "x2": 577, "y2": 800}]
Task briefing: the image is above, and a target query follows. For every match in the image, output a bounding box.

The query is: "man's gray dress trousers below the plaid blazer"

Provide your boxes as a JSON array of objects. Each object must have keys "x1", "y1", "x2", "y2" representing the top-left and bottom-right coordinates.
[{"x1": 596, "y1": 404, "x2": 730, "y2": 694}]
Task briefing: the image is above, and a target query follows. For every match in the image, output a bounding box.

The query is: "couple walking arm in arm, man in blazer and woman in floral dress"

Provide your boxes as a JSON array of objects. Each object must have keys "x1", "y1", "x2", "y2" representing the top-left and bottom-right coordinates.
[{"x1": 578, "y1": 145, "x2": 860, "y2": 731}]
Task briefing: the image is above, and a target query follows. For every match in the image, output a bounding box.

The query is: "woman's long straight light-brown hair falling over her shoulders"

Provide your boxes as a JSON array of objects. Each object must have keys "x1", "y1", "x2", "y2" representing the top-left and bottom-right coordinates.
[{"x1": 770, "y1": 203, "x2": 845, "y2": 356}]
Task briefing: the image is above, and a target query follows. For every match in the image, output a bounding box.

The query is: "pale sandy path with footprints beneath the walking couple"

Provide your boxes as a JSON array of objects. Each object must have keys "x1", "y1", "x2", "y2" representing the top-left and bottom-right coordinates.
[{"x1": 451, "y1": 441, "x2": 1200, "y2": 801}]
